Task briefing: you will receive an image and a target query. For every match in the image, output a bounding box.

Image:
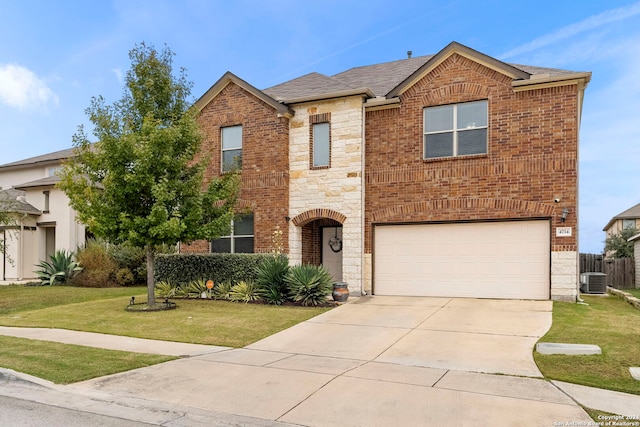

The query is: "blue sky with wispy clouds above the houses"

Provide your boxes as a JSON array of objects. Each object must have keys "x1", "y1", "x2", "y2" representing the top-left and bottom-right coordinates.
[{"x1": 0, "y1": 0, "x2": 640, "y2": 253}]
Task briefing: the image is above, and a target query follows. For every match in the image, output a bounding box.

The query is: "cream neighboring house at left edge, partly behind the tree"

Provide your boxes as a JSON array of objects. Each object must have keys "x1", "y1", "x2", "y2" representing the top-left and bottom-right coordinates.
[{"x1": 0, "y1": 149, "x2": 85, "y2": 280}]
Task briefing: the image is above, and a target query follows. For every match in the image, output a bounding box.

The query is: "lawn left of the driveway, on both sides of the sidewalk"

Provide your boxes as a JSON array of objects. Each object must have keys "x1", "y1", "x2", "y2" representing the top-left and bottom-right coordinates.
[{"x1": 0, "y1": 285, "x2": 329, "y2": 384}]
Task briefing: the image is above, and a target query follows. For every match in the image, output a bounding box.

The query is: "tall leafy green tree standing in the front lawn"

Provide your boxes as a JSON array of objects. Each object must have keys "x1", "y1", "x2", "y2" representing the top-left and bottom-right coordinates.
[{"x1": 59, "y1": 43, "x2": 239, "y2": 306}]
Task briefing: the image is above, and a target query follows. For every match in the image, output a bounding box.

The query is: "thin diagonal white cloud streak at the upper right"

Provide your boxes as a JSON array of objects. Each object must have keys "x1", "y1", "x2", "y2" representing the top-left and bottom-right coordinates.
[{"x1": 498, "y1": 3, "x2": 640, "y2": 59}]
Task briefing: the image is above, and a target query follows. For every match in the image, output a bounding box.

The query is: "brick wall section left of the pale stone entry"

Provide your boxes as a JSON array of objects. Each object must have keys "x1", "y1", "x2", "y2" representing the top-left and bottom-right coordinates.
[{"x1": 190, "y1": 83, "x2": 289, "y2": 253}]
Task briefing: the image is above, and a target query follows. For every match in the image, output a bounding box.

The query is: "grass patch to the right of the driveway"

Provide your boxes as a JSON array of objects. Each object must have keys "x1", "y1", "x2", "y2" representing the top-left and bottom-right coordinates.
[{"x1": 534, "y1": 295, "x2": 640, "y2": 394}]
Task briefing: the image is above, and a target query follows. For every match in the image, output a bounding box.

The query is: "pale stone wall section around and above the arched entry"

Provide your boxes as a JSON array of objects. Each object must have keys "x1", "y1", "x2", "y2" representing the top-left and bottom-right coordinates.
[{"x1": 288, "y1": 96, "x2": 363, "y2": 294}]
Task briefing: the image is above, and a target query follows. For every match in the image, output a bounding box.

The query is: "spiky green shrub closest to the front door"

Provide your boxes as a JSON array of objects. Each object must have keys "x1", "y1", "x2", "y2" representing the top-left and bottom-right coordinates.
[{"x1": 286, "y1": 265, "x2": 333, "y2": 306}]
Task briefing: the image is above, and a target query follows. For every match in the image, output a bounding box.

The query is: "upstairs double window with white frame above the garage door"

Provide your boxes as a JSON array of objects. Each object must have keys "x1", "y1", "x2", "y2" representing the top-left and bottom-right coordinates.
[{"x1": 424, "y1": 101, "x2": 488, "y2": 159}]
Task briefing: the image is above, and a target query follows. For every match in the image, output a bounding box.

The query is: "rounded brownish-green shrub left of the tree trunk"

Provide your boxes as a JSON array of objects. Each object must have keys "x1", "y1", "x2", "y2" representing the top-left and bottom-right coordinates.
[{"x1": 71, "y1": 239, "x2": 118, "y2": 288}]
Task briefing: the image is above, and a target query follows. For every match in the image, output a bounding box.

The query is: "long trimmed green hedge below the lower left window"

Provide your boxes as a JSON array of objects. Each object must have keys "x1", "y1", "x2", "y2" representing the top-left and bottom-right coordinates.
[{"x1": 154, "y1": 254, "x2": 272, "y2": 285}]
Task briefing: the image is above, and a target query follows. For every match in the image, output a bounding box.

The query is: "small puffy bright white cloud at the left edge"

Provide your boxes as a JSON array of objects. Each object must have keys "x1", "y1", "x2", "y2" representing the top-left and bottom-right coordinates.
[{"x1": 0, "y1": 64, "x2": 58, "y2": 110}]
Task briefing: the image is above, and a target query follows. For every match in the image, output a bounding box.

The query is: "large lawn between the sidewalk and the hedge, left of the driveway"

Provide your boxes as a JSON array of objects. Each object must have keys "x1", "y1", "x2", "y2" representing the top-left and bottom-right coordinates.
[{"x1": 0, "y1": 287, "x2": 329, "y2": 347}]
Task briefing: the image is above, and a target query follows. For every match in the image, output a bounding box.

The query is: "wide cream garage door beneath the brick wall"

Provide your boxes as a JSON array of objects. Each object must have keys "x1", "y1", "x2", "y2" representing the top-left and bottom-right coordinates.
[{"x1": 373, "y1": 221, "x2": 550, "y2": 299}]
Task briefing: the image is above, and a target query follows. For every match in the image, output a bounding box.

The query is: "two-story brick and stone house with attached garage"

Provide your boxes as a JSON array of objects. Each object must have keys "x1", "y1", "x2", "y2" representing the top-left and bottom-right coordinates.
[{"x1": 189, "y1": 43, "x2": 591, "y2": 301}]
